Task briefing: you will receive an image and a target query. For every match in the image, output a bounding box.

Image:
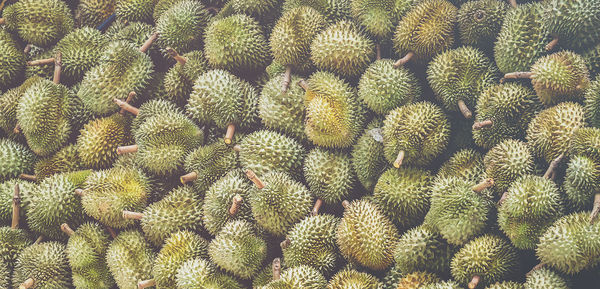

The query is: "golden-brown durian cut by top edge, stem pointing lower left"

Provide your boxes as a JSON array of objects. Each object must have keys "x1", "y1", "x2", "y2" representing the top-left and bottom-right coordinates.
[{"x1": 392, "y1": 0, "x2": 458, "y2": 67}]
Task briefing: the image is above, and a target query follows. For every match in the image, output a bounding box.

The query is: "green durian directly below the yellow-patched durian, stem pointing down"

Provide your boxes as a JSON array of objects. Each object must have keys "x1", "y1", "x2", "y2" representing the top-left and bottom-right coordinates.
[{"x1": 304, "y1": 148, "x2": 354, "y2": 204}]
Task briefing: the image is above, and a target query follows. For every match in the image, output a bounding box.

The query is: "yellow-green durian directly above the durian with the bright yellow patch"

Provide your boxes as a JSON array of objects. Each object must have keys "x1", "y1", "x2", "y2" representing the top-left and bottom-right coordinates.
[{"x1": 310, "y1": 21, "x2": 375, "y2": 78}]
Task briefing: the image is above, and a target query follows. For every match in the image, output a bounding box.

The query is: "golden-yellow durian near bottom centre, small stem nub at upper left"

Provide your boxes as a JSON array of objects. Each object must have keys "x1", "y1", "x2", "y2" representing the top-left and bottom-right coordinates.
[{"x1": 336, "y1": 200, "x2": 399, "y2": 270}]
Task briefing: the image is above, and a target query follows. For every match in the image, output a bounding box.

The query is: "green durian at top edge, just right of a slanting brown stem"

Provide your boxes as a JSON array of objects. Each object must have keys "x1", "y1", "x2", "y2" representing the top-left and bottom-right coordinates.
[{"x1": 156, "y1": 0, "x2": 211, "y2": 53}]
